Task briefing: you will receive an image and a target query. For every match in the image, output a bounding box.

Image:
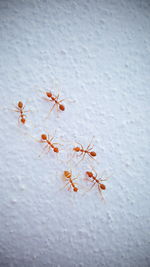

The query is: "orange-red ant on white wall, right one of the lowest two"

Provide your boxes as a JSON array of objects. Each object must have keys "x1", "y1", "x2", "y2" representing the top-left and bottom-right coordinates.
[{"x1": 86, "y1": 171, "x2": 107, "y2": 199}]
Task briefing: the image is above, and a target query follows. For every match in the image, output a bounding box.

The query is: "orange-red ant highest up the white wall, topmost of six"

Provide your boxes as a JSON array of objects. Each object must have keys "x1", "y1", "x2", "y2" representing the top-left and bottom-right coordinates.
[{"x1": 44, "y1": 92, "x2": 65, "y2": 115}]
